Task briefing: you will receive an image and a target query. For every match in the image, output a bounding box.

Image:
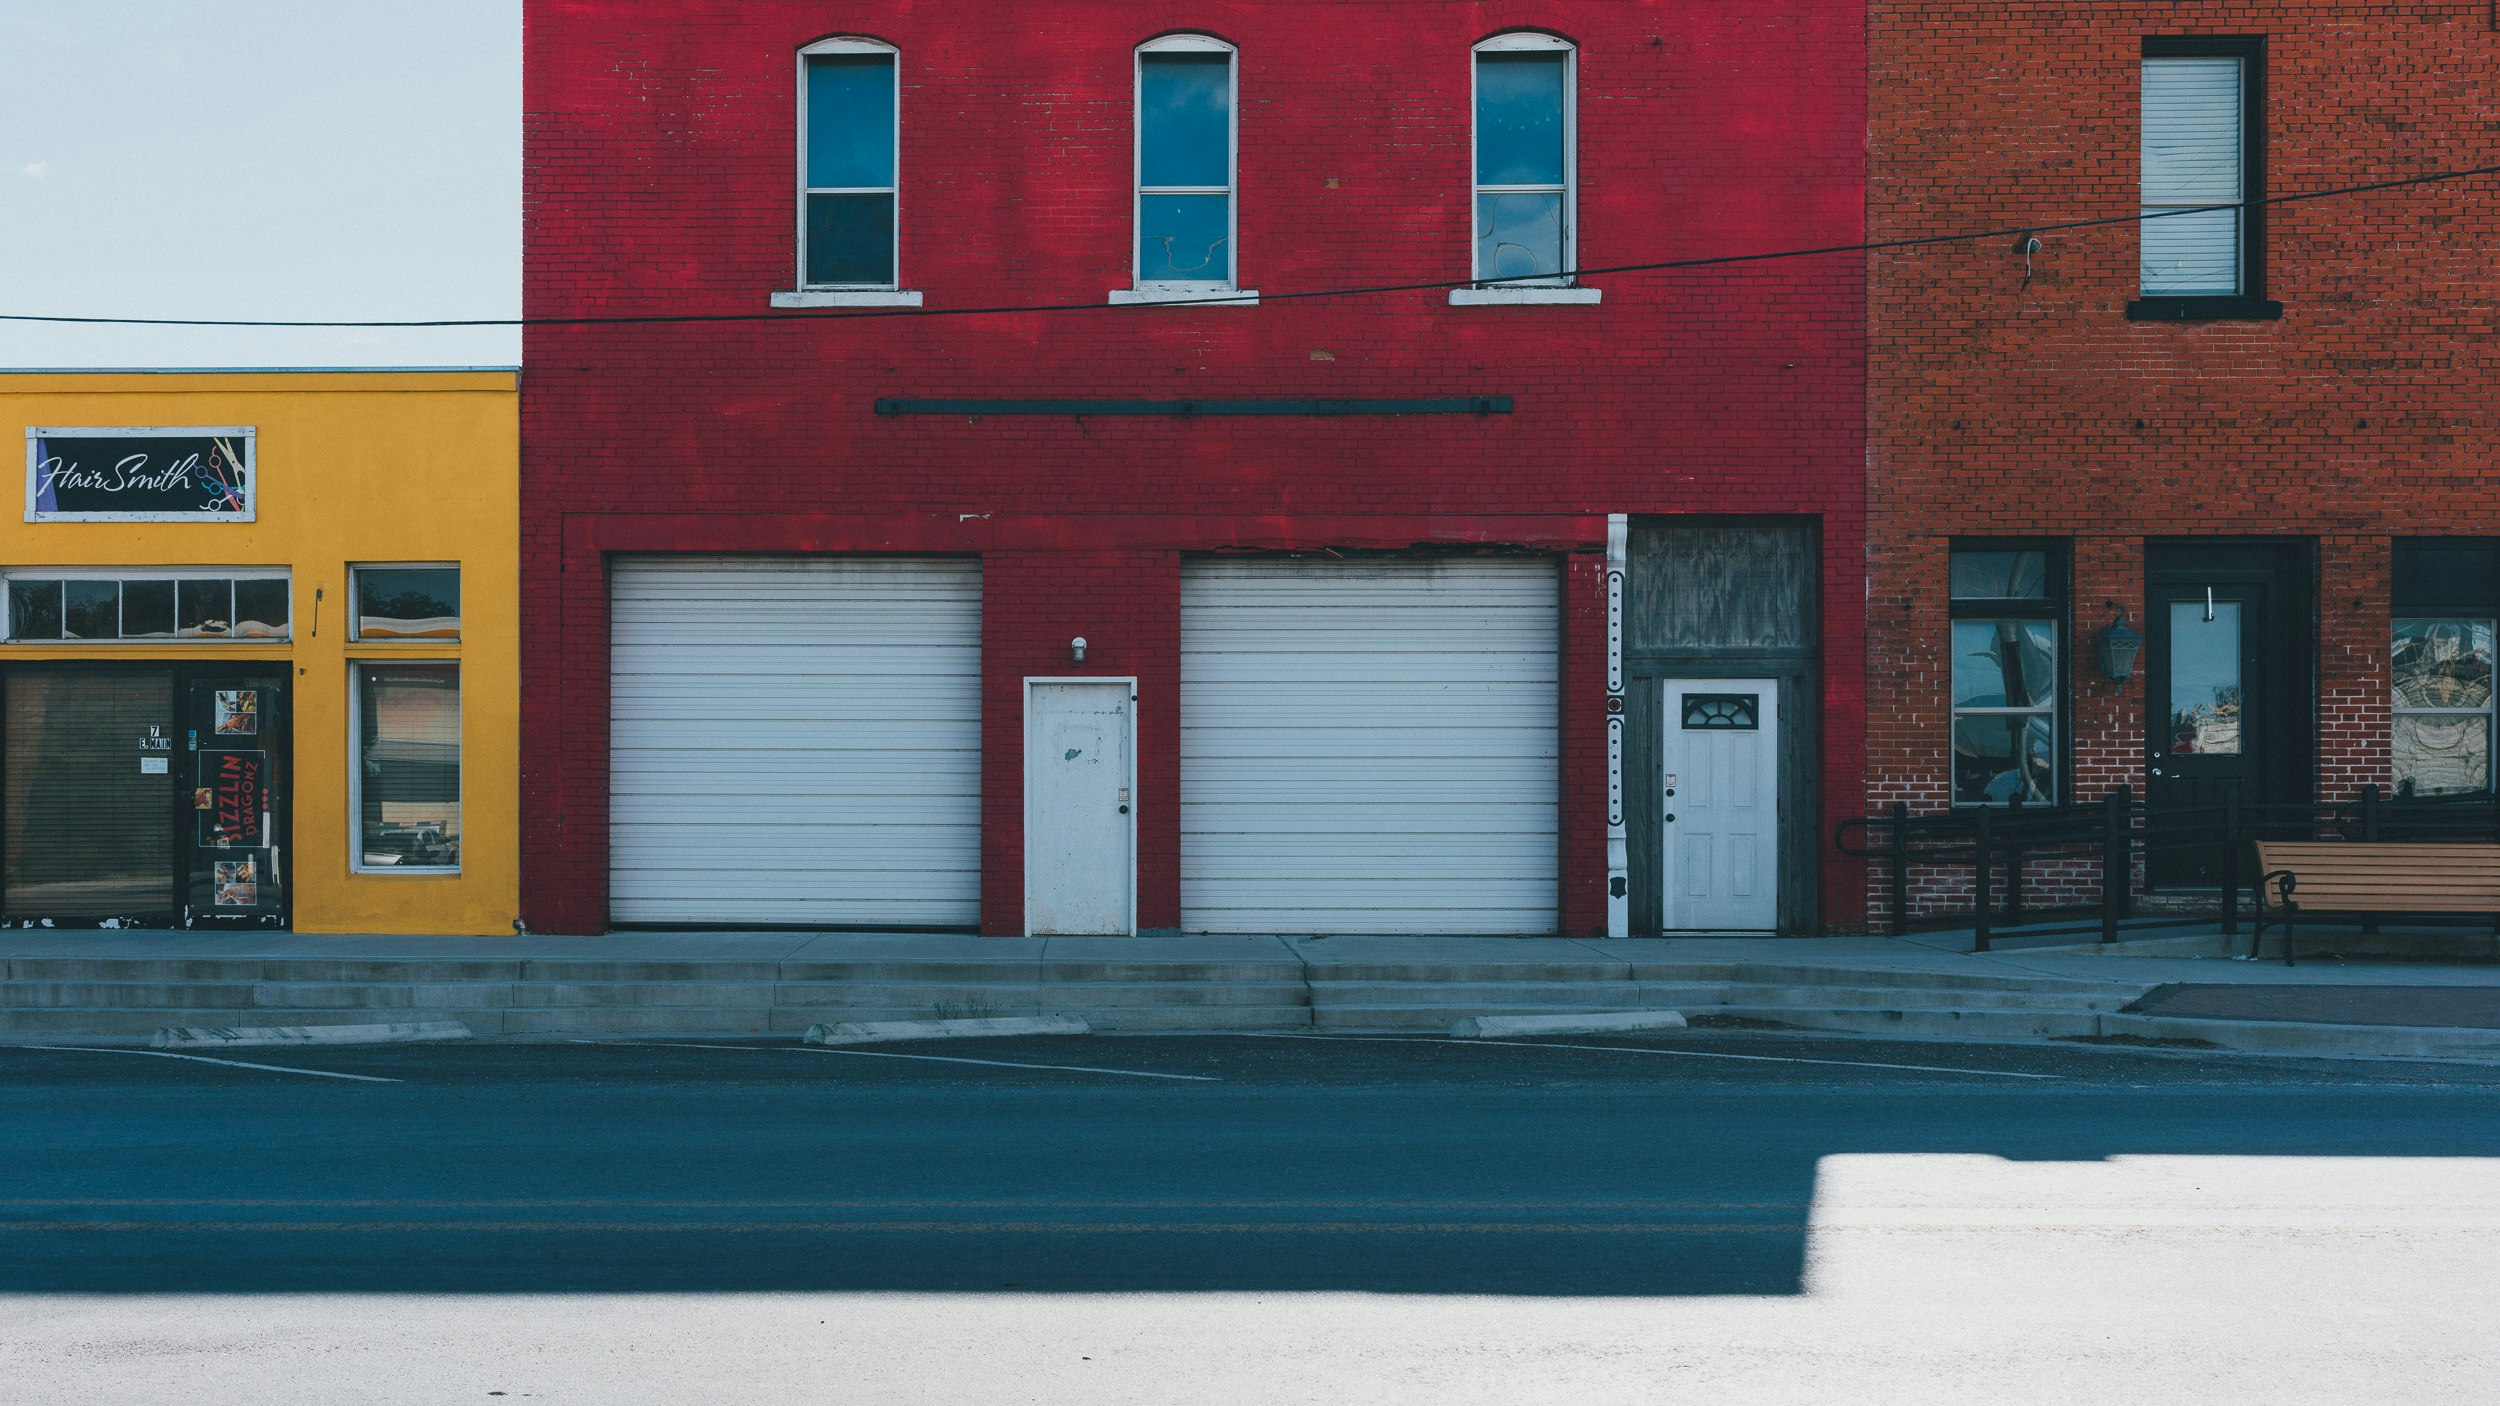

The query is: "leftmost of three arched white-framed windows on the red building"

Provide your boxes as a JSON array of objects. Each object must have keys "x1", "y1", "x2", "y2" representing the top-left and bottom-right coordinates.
[{"x1": 798, "y1": 40, "x2": 898, "y2": 288}]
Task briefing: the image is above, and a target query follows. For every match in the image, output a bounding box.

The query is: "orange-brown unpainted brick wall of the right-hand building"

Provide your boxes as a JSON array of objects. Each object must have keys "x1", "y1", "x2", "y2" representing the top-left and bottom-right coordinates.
[{"x1": 1868, "y1": 0, "x2": 2500, "y2": 916}]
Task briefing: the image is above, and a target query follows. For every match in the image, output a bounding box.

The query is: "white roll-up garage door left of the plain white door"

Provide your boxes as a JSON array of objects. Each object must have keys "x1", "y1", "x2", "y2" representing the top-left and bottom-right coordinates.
[{"x1": 608, "y1": 558, "x2": 980, "y2": 928}]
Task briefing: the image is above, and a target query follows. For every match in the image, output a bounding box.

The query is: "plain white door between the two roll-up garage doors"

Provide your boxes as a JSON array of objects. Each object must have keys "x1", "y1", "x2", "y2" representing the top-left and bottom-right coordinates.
[{"x1": 1025, "y1": 678, "x2": 1138, "y2": 938}]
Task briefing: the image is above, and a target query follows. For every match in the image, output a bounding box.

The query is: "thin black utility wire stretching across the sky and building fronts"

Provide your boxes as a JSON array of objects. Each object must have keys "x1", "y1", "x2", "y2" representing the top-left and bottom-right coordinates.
[{"x1": 0, "y1": 165, "x2": 2500, "y2": 328}]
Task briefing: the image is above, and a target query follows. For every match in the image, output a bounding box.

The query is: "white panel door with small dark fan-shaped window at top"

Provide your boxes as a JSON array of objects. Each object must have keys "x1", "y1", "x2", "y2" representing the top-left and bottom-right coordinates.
[{"x1": 1660, "y1": 678, "x2": 1780, "y2": 933}]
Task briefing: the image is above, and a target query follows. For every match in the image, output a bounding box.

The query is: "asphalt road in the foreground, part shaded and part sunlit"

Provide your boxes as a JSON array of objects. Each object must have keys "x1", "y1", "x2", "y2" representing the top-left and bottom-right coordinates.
[{"x1": 0, "y1": 1033, "x2": 2500, "y2": 1403}]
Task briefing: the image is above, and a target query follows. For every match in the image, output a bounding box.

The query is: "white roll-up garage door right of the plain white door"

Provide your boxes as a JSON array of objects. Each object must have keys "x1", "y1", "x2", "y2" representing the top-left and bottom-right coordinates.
[{"x1": 1180, "y1": 558, "x2": 1563, "y2": 933}]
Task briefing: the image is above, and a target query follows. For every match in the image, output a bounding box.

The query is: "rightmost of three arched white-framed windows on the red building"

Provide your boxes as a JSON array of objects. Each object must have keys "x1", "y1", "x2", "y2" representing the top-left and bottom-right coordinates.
[{"x1": 1475, "y1": 33, "x2": 1578, "y2": 288}]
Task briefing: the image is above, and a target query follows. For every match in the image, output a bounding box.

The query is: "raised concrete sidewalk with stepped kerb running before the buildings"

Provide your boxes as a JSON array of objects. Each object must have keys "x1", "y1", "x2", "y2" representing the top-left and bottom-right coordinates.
[{"x1": 0, "y1": 928, "x2": 2500, "y2": 1058}]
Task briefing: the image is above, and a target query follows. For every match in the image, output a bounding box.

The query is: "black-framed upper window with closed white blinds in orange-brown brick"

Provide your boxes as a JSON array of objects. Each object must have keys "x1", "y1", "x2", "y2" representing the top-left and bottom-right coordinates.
[{"x1": 2128, "y1": 38, "x2": 2280, "y2": 318}]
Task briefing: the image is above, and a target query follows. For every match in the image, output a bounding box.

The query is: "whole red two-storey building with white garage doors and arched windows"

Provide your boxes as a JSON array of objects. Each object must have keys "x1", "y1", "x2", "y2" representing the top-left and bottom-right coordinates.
[{"x1": 523, "y1": 0, "x2": 1865, "y2": 933}]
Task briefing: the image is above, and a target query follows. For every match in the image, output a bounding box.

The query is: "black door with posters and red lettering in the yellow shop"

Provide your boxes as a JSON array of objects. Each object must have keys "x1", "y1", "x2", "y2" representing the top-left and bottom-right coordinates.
[{"x1": 183, "y1": 665, "x2": 288, "y2": 928}]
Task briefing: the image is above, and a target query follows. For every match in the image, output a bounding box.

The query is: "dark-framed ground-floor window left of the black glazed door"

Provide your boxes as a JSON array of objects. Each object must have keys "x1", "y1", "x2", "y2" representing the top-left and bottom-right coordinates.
[{"x1": 1950, "y1": 543, "x2": 2065, "y2": 806}]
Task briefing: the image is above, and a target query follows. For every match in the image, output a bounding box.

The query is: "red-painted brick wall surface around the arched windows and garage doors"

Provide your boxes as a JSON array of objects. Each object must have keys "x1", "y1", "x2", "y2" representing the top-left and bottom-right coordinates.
[{"x1": 523, "y1": 0, "x2": 1865, "y2": 931}]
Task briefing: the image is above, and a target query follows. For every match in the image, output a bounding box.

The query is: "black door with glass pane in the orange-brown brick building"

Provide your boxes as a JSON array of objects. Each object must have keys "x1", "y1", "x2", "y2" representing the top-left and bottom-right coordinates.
[{"x1": 2145, "y1": 543, "x2": 2315, "y2": 888}]
